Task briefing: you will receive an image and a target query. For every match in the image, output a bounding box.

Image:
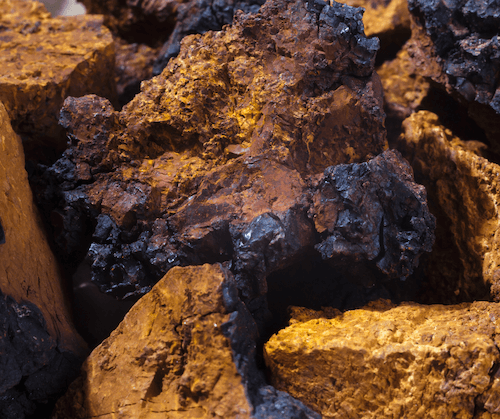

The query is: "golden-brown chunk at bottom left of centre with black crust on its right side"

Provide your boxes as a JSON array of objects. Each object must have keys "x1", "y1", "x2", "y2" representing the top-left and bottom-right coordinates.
[{"x1": 48, "y1": 264, "x2": 319, "y2": 419}]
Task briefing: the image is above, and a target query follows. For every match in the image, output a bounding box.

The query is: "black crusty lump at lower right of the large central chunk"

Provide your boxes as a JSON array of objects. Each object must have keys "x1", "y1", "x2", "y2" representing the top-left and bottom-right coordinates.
[{"x1": 311, "y1": 148, "x2": 435, "y2": 280}]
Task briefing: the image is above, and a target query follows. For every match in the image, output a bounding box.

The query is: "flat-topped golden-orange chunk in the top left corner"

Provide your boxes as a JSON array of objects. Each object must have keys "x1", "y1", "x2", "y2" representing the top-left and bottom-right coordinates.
[{"x1": 0, "y1": 0, "x2": 116, "y2": 153}]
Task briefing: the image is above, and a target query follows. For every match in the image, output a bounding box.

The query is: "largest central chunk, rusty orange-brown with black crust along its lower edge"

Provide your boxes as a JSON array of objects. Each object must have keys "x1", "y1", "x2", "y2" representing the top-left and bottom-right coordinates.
[{"x1": 35, "y1": 0, "x2": 394, "y2": 306}]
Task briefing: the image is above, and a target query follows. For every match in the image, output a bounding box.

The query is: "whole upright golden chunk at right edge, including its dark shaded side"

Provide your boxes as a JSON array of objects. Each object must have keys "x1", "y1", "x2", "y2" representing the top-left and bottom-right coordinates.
[{"x1": 399, "y1": 111, "x2": 500, "y2": 302}]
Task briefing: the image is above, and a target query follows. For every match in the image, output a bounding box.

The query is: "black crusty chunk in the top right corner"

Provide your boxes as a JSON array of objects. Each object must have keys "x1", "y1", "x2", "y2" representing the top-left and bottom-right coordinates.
[{"x1": 408, "y1": 0, "x2": 500, "y2": 115}]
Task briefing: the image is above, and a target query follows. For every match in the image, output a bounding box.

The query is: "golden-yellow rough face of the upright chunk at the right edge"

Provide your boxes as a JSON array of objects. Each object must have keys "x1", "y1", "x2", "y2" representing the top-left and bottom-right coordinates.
[{"x1": 400, "y1": 111, "x2": 500, "y2": 301}]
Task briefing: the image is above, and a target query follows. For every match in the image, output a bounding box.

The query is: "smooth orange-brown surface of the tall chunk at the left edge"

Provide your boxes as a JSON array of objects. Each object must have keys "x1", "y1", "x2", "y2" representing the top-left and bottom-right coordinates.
[{"x1": 0, "y1": 102, "x2": 86, "y2": 356}]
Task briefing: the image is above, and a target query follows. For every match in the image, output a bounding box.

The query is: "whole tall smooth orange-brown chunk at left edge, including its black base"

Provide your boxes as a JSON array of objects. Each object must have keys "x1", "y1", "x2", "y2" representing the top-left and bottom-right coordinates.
[{"x1": 0, "y1": 102, "x2": 86, "y2": 419}]
